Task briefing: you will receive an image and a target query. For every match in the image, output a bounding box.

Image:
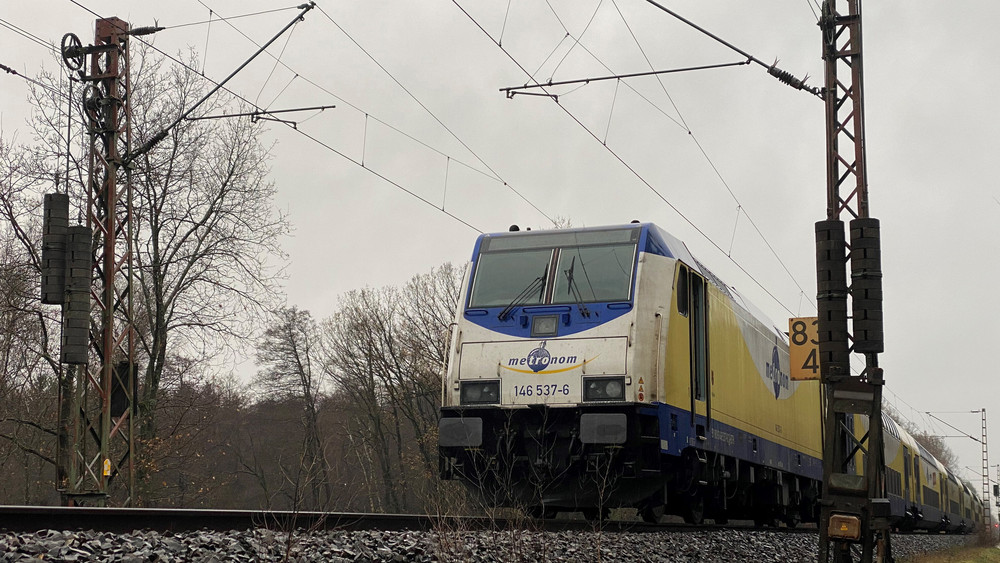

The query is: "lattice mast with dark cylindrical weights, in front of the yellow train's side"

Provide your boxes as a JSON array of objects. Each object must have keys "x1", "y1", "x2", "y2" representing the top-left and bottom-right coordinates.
[{"x1": 816, "y1": 0, "x2": 892, "y2": 563}]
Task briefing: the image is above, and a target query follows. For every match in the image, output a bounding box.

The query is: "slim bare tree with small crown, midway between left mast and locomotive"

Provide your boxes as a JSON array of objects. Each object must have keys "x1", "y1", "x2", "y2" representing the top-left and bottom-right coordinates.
[{"x1": 254, "y1": 307, "x2": 331, "y2": 508}]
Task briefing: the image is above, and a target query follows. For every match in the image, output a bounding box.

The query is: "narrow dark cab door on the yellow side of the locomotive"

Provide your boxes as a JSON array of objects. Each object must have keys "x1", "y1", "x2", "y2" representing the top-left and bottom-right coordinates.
[{"x1": 677, "y1": 265, "x2": 711, "y2": 439}]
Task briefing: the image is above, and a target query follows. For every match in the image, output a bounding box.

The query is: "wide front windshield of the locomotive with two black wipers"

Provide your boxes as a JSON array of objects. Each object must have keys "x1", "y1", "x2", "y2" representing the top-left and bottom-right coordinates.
[{"x1": 469, "y1": 228, "x2": 640, "y2": 307}]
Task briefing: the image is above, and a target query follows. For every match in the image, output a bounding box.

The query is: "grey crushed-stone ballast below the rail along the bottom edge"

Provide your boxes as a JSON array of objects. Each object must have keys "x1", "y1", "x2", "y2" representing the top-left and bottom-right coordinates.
[{"x1": 0, "y1": 529, "x2": 972, "y2": 563}]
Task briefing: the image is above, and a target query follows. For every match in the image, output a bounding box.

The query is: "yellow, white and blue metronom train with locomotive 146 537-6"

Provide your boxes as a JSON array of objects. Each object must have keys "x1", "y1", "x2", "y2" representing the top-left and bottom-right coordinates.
[{"x1": 438, "y1": 223, "x2": 982, "y2": 531}]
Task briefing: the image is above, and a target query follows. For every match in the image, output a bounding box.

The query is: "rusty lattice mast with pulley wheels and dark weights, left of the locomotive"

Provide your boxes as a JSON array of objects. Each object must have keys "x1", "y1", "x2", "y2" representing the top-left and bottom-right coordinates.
[{"x1": 60, "y1": 18, "x2": 136, "y2": 506}]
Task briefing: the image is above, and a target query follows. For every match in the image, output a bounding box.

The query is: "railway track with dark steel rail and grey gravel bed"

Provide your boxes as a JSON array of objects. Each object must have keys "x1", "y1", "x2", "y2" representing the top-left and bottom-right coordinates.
[{"x1": 0, "y1": 506, "x2": 969, "y2": 563}]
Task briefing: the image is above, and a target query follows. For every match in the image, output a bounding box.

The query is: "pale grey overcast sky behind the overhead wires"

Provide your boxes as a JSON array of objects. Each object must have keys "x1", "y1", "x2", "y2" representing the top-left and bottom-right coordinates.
[{"x1": 0, "y1": 0, "x2": 1000, "y2": 498}]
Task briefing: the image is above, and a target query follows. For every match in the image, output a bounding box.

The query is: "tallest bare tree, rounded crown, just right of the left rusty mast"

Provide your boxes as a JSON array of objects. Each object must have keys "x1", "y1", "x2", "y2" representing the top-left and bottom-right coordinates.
[{"x1": 132, "y1": 46, "x2": 287, "y2": 438}]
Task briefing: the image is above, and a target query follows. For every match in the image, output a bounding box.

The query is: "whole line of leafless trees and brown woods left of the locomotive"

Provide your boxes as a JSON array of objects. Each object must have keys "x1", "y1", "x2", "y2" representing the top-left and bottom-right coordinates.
[{"x1": 0, "y1": 44, "x2": 472, "y2": 511}]
